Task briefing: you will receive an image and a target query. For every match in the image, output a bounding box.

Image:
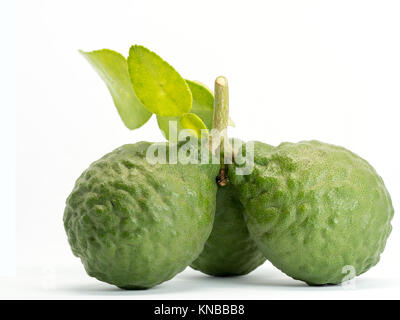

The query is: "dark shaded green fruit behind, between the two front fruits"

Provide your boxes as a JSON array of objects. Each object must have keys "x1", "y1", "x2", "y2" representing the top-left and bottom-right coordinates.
[{"x1": 191, "y1": 184, "x2": 265, "y2": 276}]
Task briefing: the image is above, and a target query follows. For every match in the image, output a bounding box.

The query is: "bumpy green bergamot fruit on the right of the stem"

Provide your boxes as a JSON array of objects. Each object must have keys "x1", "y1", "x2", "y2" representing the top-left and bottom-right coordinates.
[{"x1": 230, "y1": 141, "x2": 394, "y2": 285}]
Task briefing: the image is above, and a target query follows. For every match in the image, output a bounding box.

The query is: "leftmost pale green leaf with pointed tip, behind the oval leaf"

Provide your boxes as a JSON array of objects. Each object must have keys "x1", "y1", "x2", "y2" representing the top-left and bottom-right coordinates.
[{"x1": 80, "y1": 49, "x2": 151, "y2": 130}]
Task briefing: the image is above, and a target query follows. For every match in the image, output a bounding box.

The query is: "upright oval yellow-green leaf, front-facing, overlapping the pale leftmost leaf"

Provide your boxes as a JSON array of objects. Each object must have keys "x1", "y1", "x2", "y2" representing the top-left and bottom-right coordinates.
[{"x1": 128, "y1": 45, "x2": 192, "y2": 117}]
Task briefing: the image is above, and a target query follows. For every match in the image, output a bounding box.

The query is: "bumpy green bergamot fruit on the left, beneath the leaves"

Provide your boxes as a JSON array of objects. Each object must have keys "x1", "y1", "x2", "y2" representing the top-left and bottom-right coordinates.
[{"x1": 64, "y1": 142, "x2": 218, "y2": 289}]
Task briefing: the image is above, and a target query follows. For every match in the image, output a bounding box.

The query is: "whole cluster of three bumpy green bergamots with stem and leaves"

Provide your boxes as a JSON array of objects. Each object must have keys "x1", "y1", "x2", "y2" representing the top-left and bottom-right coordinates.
[{"x1": 74, "y1": 45, "x2": 393, "y2": 289}]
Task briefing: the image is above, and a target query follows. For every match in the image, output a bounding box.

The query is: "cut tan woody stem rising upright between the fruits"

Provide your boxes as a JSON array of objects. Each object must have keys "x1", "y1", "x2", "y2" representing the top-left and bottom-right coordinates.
[{"x1": 210, "y1": 76, "x2": 232, "y2": 187}]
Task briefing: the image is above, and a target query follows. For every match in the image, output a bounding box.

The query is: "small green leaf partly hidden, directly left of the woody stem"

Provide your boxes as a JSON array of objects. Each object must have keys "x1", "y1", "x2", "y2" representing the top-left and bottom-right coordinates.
[{"x1": 186, "y1": 80, "x2": 214, "y2": 129}]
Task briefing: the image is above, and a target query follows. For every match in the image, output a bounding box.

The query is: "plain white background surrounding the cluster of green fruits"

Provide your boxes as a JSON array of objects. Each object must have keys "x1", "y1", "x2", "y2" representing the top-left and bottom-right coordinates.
[{"x1": 0, "y1": 0, "x2": 400, "y2": 299}]
